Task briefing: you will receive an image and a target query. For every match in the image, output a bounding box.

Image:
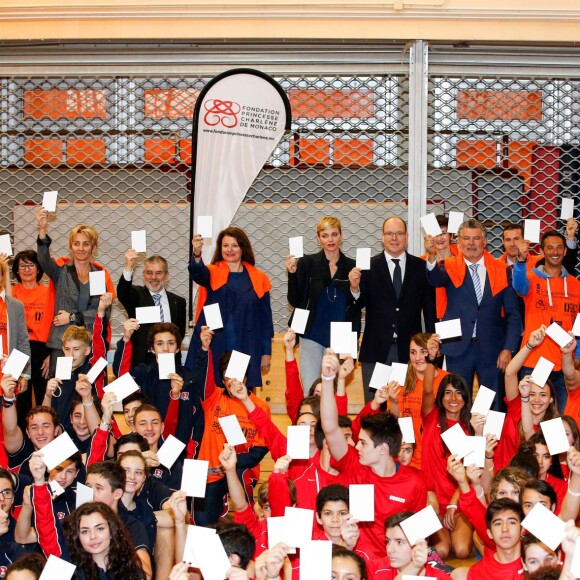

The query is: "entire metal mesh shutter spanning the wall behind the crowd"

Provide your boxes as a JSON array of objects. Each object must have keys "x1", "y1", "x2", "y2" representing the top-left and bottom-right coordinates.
[{"x1": 0, "y1": 46, "x2": 580, "y2": 344}]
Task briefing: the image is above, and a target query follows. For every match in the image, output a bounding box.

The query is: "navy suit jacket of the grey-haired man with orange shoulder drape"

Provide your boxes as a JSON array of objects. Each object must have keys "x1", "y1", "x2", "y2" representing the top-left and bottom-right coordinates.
[{"x1": 427, "y1": 258, "x2": 522, "y2": 360}]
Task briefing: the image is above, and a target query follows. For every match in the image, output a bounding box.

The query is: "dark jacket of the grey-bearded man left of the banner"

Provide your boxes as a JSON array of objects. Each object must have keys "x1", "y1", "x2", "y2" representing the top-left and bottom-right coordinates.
[{"x1": 117, "y1": 274, "x2": 187, "y2": 367}]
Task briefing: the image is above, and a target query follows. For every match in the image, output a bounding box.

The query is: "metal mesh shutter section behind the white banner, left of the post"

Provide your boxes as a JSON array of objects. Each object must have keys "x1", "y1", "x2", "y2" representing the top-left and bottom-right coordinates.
[{"x1": 0, "y1": 69, "x2": 409, "y2": 335}]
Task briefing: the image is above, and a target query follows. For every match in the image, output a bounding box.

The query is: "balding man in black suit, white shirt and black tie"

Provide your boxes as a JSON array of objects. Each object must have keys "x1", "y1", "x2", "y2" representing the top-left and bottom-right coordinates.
[{"x1": 349, "y1": 217, "x2": 435, "y2": 402}]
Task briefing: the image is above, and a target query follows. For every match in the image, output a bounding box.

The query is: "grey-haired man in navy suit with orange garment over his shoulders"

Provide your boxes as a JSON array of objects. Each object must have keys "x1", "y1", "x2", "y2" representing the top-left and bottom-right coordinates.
[{"x1": 426, "y1": 219, "x2": 522, "y2": 409}]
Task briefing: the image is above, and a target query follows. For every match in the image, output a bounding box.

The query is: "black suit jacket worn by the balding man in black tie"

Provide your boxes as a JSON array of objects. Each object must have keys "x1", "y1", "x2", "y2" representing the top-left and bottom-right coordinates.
[{"x1": 356, "y1": 252, "x2": 435, "y2": 363}]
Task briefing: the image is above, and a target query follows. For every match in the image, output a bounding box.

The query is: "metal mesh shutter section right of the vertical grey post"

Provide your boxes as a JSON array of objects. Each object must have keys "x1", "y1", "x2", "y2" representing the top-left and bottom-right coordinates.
[{"x1": 427, "y1": 72, "x2": 580, "y2": 256}]
